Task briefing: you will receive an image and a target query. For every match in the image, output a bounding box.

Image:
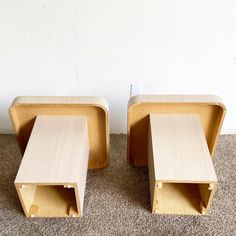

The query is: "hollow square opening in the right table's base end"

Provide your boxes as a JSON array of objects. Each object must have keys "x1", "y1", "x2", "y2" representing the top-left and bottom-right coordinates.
[{"x1": 153, "y1": 183, "x2": 212, "y2": 215}]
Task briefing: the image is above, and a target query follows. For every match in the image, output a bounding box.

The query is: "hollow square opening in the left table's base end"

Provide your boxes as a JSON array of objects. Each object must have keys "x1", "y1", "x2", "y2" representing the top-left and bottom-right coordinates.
[{"x1": 17, "y1": 184, "x2": 79, "y2": 217}]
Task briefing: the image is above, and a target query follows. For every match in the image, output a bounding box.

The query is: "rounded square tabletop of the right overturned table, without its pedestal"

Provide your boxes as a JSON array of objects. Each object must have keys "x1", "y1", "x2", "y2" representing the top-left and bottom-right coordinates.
[{"x1": 127, "y1": 95, "x2": 225, "y2": 166}]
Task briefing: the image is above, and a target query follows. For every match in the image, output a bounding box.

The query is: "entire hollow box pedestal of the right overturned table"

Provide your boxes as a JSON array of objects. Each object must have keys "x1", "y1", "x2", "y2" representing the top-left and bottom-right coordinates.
[{"x1": 148, "y1": 114, "x2": 217, "y2": 215}]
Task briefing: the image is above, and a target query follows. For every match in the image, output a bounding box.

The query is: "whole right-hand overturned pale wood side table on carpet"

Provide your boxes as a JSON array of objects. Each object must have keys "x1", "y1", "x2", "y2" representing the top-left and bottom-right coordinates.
[{"x1": 127, "y1": 95, "x2": 225, "y2": 215}]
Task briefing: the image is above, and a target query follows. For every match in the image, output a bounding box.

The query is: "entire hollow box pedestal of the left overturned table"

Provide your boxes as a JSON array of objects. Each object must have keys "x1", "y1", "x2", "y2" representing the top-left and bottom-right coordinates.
[{"x1": 15, "y1": 116, "x2": 89, "y2": 217}]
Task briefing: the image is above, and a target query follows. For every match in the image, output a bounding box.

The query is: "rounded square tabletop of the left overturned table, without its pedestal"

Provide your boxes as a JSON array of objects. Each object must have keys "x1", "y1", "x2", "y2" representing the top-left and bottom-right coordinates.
[{"x1": 9, "y1": 96, "x2": 109, "y2": 169}]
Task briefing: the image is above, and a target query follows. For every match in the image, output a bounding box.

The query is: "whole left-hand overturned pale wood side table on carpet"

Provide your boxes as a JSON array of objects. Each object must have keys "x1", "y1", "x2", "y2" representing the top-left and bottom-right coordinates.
[{"x1": 9, "y1": 97, "x2": 109, "y2": 217}]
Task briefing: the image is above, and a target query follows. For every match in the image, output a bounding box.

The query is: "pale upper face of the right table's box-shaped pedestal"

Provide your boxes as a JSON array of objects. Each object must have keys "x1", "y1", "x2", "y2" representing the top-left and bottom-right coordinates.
[{"x1": 150, "y1": 114, "x2": 217, "y2": 183}]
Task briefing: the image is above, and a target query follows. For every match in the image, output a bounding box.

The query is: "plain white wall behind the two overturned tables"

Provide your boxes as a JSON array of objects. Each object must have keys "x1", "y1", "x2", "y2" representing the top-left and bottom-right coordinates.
[{"x1": 0, "y1": 0, "x2": 236, "y2": 133}]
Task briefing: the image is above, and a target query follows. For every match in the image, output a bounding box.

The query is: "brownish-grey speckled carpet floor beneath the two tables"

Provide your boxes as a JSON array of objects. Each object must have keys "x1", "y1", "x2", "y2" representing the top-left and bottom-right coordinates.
[{"x1": 0, "y1": 135, "x2": 236, "y2": 236}]
